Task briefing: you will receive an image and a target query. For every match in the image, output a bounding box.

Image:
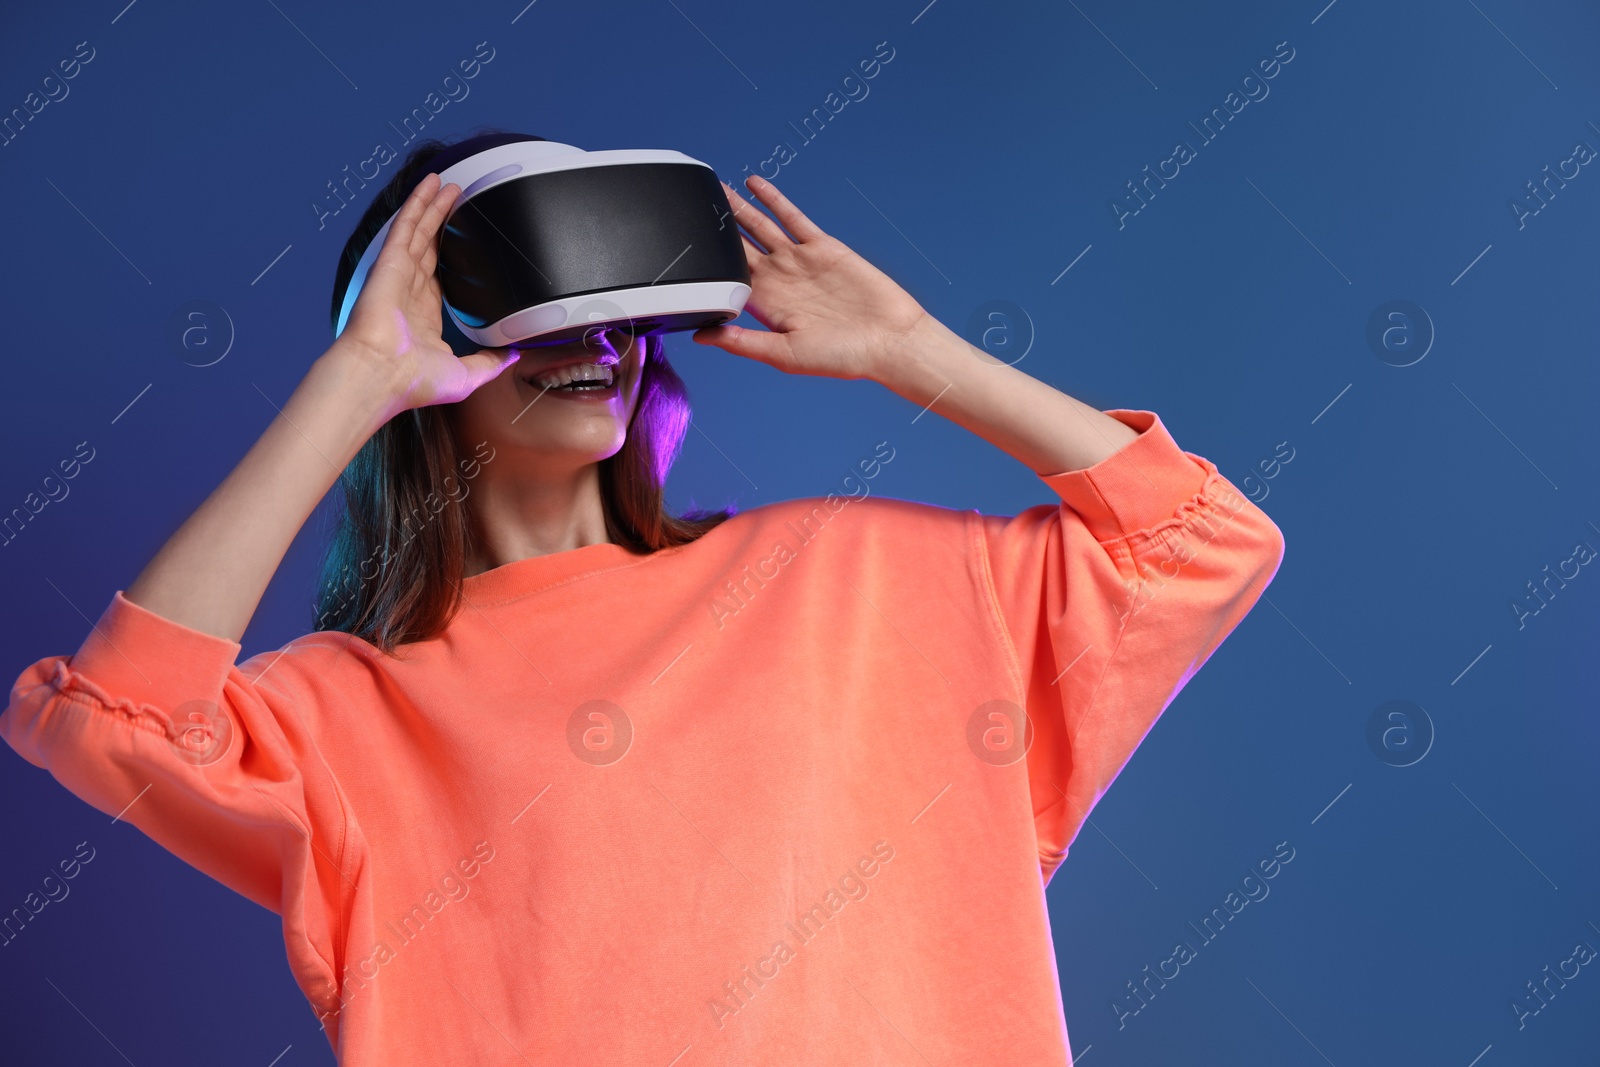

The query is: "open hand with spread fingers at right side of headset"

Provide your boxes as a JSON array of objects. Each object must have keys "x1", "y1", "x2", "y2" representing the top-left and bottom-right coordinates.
[{"x1": 693, "y1": 176, "x2": 931, "y2": 381}]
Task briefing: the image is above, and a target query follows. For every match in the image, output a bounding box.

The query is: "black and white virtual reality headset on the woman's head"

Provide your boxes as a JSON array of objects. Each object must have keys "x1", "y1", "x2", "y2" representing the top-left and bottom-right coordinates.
[{"x1": 334, "y1": 134, "x2": 750, "y2": 355}]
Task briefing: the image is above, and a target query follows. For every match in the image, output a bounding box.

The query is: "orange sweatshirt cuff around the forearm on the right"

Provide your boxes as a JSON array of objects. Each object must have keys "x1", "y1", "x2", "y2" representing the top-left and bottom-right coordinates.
[{"x1": 1038, "y1": 408, "x2": 1216, "y2": 542}]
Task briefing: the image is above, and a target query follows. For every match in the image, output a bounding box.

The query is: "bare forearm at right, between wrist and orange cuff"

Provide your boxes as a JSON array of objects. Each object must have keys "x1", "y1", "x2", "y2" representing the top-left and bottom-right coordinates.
[{"x1": 874, "y1": 315, "x2": 1138, "y2": 475}]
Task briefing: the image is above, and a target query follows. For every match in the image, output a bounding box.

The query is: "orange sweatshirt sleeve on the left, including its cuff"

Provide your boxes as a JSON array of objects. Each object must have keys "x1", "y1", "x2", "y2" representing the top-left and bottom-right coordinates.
[{"x1": 0, "y1": 590, "x2": 346, "y2": 995}]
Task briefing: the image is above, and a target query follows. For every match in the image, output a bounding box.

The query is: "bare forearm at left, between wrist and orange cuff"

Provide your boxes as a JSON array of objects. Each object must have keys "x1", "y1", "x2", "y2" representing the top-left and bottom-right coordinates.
[{"x1": 123, "y1": 344, "x2": 394, "y2": 641}]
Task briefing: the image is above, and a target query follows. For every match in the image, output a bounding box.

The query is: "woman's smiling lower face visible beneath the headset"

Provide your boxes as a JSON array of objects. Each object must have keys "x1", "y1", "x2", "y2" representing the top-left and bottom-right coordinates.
[{"x1": 451, "y1": 328, "x2": 645, "y2": 477}]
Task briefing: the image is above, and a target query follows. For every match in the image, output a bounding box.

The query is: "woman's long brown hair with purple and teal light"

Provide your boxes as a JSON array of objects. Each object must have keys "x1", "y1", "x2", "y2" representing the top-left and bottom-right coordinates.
[{"x1": 314, "y1": 128, "x2": 734, "y2": 654}]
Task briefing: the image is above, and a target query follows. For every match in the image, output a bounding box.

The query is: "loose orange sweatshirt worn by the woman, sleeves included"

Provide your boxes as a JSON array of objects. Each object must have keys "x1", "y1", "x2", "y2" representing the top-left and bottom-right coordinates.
[{"x1": 0, "y1": 410, "x2": 1283, "y2": 1067}]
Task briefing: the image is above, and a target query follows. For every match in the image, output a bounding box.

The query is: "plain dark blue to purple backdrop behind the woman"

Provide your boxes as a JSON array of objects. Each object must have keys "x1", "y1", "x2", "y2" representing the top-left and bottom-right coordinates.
[{"x1": 0, "y1": 0, "x2": 1600, "y2": 1067}]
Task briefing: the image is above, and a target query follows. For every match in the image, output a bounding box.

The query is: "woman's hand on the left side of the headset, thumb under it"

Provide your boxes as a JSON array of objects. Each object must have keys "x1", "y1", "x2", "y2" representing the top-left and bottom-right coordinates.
[{"x1": 334, "y1": 173, "x2": 518, "y2": 414}]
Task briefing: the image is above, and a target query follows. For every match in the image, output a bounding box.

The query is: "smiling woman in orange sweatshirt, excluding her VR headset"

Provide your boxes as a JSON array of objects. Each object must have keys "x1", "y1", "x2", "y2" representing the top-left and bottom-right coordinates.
[{"x1": 0, "y1": 134, "x2": 1283, "y2": 1067}]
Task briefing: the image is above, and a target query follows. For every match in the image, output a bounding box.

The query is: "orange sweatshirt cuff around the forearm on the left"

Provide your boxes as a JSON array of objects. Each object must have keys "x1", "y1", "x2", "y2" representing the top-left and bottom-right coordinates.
[{"x1": 72, "y1": 589, "x2": 240, "y2": 712}]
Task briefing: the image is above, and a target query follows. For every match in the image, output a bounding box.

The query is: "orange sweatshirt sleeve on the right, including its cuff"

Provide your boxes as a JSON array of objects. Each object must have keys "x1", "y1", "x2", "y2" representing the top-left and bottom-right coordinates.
[{"x1": 978, "y1": 410, "x2": 1283, "y2": 883}]
